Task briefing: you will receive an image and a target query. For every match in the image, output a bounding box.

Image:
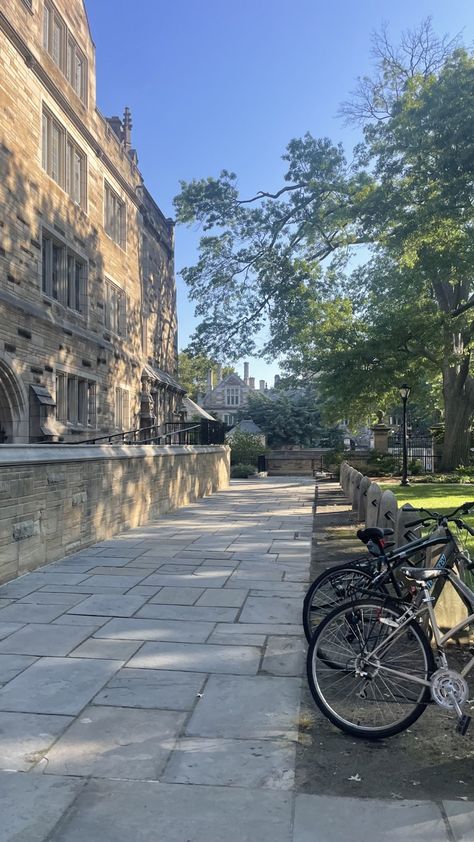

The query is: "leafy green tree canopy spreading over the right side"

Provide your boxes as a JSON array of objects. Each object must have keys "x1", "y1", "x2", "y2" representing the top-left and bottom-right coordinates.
[{"x1": 176, "y1": 21, "x2": 474, "y2": 466}]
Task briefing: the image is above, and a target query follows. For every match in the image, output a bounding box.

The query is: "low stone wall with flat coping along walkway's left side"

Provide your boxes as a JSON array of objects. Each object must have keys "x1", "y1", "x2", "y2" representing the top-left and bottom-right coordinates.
[{"x1": 0, "y1": 445, "x2": 230, "y2": 582}]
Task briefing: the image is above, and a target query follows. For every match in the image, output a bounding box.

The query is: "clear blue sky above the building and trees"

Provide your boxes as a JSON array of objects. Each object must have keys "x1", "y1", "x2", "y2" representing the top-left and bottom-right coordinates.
[{"x1": 86, "y1": 0, "x2": 474, "y2": 383}]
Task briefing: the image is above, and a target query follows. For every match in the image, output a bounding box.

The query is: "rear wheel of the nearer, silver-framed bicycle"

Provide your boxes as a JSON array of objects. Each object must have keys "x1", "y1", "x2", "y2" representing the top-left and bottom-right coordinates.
[{"x1": 307, "y1": 598, "x2": 435, "y2": 739}]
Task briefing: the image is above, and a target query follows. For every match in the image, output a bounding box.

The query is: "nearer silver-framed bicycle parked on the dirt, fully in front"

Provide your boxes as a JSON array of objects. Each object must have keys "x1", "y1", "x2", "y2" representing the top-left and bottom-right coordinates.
[{"x1": 307, "y1": 521, "x2": 474, "y2": 739}]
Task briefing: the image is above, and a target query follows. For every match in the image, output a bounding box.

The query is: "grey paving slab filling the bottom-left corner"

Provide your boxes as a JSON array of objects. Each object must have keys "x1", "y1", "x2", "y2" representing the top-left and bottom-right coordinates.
[{"x1": 0, "y1": 772, "x2": 85, "y2": 842}]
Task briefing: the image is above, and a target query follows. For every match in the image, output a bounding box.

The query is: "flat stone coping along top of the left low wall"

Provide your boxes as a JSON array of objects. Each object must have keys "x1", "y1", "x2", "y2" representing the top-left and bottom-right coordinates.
[{"x1": 0, "y1": 444, "x2": 230, "y2": 467}]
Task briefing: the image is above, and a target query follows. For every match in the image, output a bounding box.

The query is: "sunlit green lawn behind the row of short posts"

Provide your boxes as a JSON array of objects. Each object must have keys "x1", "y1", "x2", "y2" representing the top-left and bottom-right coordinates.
[{"x1": 380, "y1": 483, "x2": 474, "y2": 558}]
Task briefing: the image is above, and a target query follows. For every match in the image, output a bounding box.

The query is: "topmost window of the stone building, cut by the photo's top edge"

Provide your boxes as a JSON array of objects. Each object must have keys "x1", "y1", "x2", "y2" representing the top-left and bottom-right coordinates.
[{"x1": 43, "y1": 0, "x2": 87, "y2": 103}]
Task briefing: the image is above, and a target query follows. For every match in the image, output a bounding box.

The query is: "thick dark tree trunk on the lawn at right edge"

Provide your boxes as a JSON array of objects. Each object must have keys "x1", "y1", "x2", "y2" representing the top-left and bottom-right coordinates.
[{"x1": 441, "y1": 366, "x2": 474, "y2": 471}]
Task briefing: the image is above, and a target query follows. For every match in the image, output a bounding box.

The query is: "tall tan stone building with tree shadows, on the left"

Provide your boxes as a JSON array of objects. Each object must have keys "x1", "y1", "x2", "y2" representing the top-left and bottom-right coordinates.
[{"x1": 0, "y1": 0, "x2": 183, "y2": 443}]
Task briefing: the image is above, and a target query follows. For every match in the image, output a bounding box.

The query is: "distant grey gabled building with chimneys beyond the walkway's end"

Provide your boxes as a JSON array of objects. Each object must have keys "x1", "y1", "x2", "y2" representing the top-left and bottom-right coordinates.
[{"x1": 198, "y1": 363, "x2": 278, "y2": 427}]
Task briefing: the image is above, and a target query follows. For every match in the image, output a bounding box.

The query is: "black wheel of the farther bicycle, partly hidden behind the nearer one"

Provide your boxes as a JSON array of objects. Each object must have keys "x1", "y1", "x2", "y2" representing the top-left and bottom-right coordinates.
[{"x1": 303, "y1": 559, "x2": 386, "y2": 643}]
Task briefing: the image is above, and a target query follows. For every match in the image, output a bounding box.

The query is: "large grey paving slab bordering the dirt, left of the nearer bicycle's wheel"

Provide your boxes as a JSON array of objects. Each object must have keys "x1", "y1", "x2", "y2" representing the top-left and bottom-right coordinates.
[{"x1": 186, "y1": 675, "x2": 301, "y2": 740}]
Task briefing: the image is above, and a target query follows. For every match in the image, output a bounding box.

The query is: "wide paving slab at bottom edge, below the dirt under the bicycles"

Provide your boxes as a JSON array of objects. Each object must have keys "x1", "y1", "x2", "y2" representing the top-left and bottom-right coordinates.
[{"x1": 294, "y1": 795, "x2": 450, "y2": 842}]
